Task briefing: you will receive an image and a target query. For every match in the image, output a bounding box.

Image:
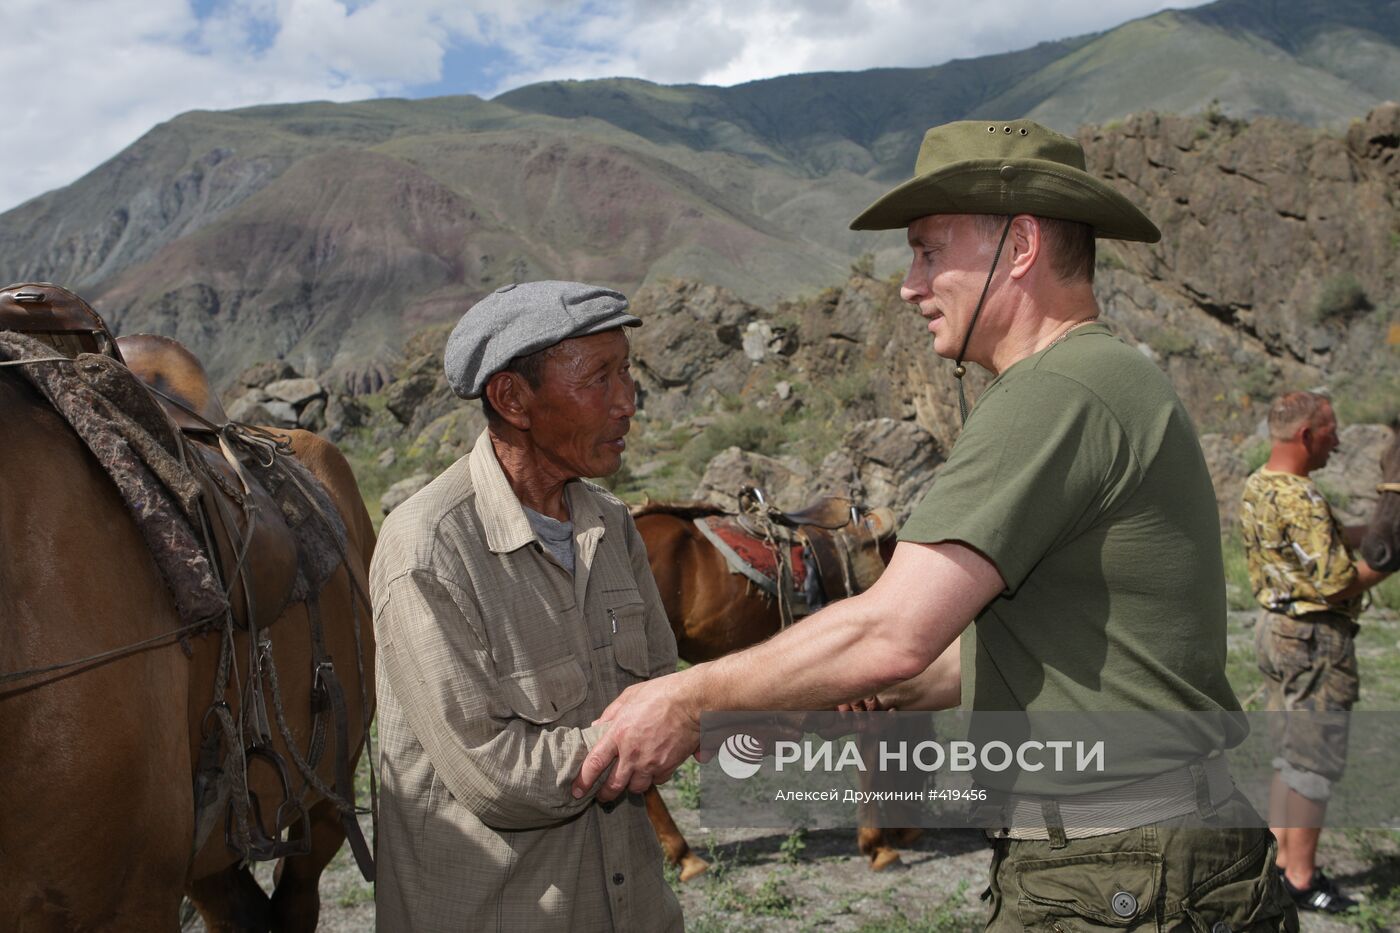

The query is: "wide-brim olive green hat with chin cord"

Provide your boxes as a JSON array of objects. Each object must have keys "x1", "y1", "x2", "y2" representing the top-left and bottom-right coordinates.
[{"x1": 851, "y1": 120, "x2": 1162, "y2": 242}]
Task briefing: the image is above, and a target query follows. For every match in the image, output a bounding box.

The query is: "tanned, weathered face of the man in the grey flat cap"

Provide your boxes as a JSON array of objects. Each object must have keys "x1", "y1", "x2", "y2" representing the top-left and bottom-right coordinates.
[{"x1": 525, "y1": 328, "x2": 637, "y2": 478}]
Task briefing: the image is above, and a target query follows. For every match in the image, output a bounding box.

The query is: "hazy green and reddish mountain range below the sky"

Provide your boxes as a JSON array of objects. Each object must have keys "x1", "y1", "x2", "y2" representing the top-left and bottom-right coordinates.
[{"x1": 0, "y1": 0, "x2": 1400, "y2": 391}]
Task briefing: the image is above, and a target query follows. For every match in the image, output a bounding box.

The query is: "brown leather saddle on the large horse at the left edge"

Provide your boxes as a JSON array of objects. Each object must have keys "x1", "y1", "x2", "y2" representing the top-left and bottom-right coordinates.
[{"x1": 0, "y1": 282, "x2": 297, "y2": 629}]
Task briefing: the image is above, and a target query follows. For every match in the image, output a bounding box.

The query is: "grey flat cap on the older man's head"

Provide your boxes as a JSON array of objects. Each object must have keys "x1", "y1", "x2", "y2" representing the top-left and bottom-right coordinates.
[{"x1": 444, "y1": 282, "x2": 641, "y2": 398}]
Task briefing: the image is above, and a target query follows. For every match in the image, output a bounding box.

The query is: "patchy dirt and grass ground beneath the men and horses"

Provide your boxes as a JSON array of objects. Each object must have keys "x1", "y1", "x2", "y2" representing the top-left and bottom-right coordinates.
[{"x1": 189, "y1": 614, "x2": 1400, "y2": 933}]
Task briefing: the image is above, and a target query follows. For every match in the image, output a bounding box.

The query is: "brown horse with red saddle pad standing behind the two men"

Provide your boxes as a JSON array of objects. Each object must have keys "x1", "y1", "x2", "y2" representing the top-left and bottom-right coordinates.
[{"x1": 636, "y1": 503, "x2": 918, "y2": 881}]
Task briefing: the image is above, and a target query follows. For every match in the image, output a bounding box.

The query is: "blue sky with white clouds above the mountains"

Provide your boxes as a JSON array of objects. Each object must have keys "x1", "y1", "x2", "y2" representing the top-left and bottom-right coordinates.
[{"x1": 0, "y1": 0, "x2": 1200, "y2": 210}]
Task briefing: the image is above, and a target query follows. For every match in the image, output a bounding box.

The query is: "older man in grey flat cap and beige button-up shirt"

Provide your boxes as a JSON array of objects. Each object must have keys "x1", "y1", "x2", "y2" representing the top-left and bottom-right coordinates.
[{"x1": 370, "y1": 282, "x2": 682, "y2": 933}]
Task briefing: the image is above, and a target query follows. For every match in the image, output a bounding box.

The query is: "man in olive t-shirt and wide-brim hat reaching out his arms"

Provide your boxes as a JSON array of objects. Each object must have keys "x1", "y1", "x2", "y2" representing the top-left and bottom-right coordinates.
[{"x1": 574, "y1": 120, "x2": 1296, "y2": 932}]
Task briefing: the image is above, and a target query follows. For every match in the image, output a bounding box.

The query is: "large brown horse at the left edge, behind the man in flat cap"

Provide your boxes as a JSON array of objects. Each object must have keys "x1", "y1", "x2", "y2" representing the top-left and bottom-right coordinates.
[{"x1": 0, "y1": 368, "x2": 374, "y2": 930}]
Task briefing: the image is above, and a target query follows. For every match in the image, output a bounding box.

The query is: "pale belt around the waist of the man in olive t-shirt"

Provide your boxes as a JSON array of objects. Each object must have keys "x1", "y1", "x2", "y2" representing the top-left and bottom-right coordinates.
[{"x1": 987, "y1": 752, "x2": 1235, "y2": 839}]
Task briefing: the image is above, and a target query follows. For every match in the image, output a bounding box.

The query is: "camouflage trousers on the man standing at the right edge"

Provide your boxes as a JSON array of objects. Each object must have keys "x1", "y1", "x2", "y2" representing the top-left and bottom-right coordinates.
[{"x1": 1254, "y1": 609, "x2": 1361, "y2": 801}]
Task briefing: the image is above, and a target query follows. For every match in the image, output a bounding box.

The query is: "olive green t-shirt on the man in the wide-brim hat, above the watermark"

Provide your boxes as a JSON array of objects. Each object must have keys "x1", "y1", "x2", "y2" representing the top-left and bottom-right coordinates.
[{"x1": 899, "y1": 324, "x2": 1245, "y2": 773}]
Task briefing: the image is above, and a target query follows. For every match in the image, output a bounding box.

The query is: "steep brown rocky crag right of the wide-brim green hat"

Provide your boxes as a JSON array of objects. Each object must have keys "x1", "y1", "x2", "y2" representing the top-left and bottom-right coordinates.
[{"x1": 1081, "y1": 104, "x2": 1400, "y2": 433}]
